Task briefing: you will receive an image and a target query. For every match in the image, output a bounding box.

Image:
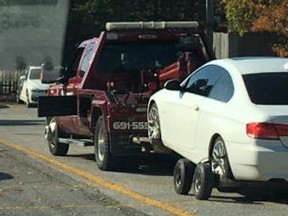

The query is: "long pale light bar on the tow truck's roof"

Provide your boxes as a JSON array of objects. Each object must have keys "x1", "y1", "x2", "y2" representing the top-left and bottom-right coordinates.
[{"x1": 106, "y1": 21, "x2": 199, "y2": 31}]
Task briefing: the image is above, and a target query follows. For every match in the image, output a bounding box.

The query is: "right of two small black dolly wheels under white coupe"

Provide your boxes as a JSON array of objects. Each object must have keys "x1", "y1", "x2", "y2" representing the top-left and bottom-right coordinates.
[{"x1": 193, "y1": 163, "x2": 214, "y2": 200}]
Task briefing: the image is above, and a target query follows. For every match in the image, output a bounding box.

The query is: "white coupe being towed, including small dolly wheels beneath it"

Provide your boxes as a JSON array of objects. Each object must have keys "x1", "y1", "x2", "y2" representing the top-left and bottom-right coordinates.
[{"x1": 148, "y1": 57, "x2": 288, "y2": 199}]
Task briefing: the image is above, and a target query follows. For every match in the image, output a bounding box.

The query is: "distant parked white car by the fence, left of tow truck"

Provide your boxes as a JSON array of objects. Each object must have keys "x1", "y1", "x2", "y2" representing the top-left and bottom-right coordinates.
[{"x1": 19, "y1": 66, "x2": 49, "y2": 107}]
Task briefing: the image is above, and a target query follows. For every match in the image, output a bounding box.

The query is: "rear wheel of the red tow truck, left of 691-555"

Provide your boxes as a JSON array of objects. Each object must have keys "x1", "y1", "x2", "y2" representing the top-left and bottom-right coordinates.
[{"x1": 94, "y1": 116, "x2": 114, "y2": 171}]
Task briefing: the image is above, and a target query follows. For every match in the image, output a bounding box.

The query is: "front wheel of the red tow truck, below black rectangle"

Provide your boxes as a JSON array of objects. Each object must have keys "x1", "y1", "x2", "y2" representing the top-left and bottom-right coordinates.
[{"x1": 47, "y1": 119, "x2": 69, "y2": 156}]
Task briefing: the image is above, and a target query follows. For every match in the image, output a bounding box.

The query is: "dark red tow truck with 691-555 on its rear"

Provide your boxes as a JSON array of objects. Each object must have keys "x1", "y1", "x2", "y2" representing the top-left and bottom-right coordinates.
[{"x1": 38, "y1": 21, "x2": 214, "y2": 170}]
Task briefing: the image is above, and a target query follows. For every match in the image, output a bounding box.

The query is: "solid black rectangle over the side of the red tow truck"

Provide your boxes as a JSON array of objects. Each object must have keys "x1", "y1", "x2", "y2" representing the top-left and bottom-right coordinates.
[{"x1": 38, "y1": 96, "x2": 77, "y2": 117}]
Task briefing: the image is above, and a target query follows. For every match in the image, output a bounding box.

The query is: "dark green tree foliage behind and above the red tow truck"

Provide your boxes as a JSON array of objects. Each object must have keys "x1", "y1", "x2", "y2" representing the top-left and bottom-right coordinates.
[{"x1": 63, "y1": 0, "x2": 205, "y2": 63}]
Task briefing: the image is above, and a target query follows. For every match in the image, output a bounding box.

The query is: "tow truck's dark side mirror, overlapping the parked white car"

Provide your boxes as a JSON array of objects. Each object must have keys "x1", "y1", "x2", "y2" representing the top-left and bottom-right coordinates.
[{"x1": 41, "y1": 64, "x2": 65, "y2": 84}]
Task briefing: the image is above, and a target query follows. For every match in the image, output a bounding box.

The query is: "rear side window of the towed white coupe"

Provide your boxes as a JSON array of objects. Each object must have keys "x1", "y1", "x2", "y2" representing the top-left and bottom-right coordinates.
[{"x1": 209, "y1": 69, "x2": 234, "y2": 102}]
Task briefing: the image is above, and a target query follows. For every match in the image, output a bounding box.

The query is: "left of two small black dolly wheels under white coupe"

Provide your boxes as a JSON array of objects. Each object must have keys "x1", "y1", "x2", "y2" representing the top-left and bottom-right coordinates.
[{"x1": 174, "y1": 158, "x2": 195, "y2": 195}]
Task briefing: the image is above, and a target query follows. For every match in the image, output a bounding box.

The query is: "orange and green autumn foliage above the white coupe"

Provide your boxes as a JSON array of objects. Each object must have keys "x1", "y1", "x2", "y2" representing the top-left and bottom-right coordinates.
[{"x1": 222, "y1": 0, "x2": 288, "y2": 56}]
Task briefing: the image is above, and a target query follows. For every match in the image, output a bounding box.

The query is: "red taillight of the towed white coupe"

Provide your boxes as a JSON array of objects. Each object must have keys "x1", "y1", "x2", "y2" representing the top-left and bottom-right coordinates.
[{"x1": 246, "y1": 122, "x2": 288, "y2": 139}]
